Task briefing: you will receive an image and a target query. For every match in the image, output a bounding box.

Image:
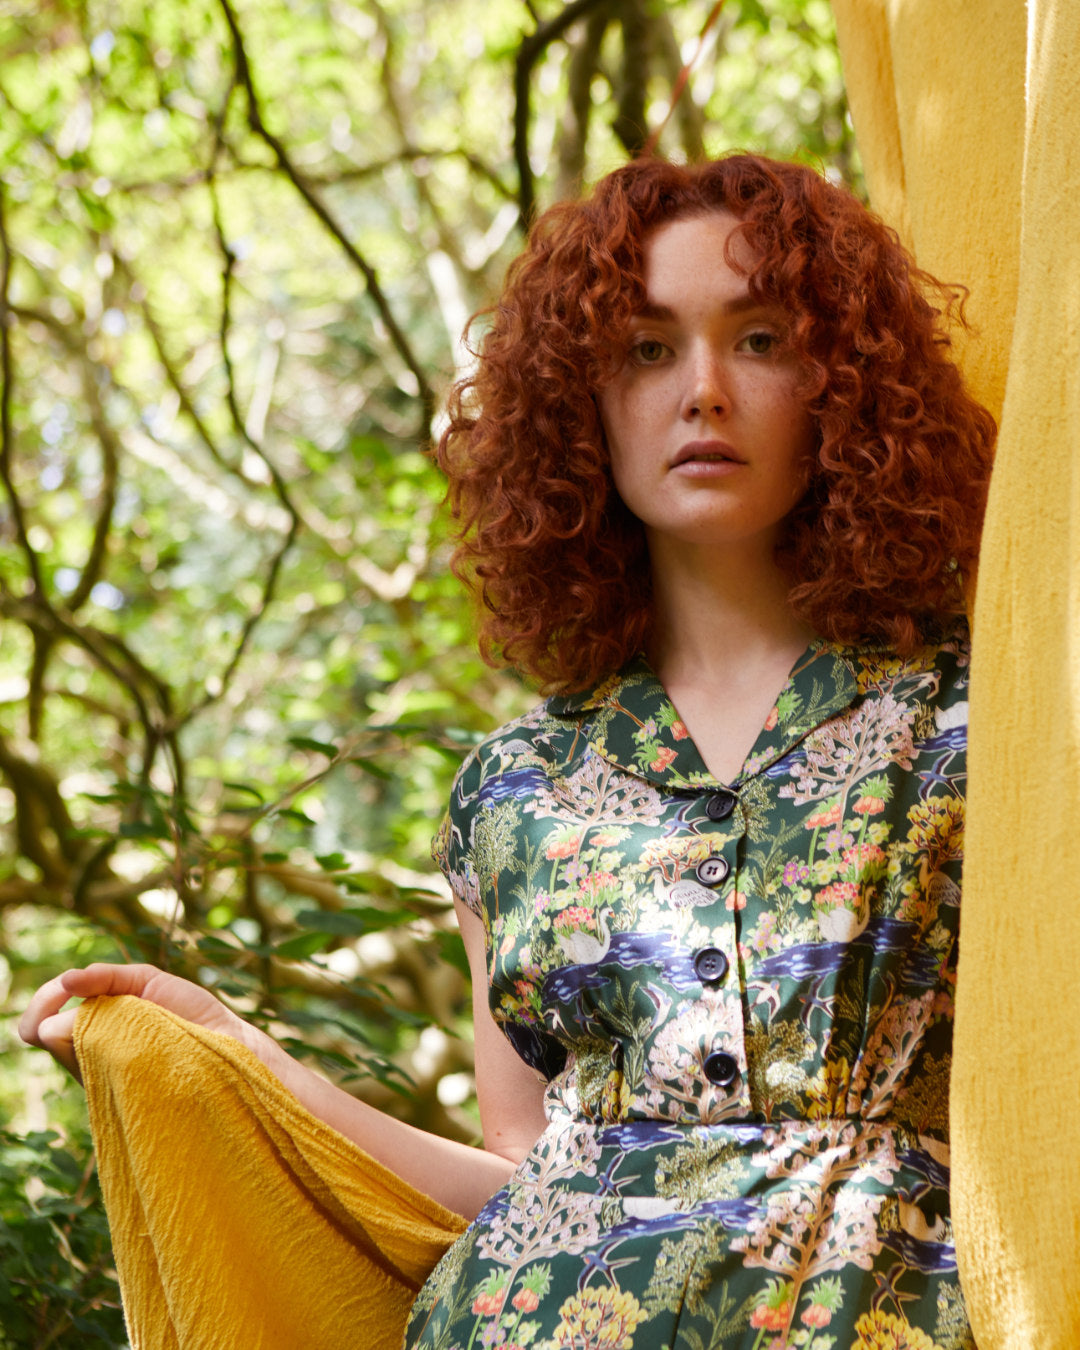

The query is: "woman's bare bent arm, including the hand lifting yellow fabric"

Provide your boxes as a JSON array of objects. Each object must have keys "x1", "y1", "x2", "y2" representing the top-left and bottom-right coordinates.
[{"x1": 19, "y1": 903, "x2": 545, "y2": 1219}]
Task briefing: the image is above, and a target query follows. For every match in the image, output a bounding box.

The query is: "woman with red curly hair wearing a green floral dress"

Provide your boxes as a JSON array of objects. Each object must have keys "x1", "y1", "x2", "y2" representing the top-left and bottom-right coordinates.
[{"x1": 23, "y1": 155, "x2": 994, "y2": 1350}]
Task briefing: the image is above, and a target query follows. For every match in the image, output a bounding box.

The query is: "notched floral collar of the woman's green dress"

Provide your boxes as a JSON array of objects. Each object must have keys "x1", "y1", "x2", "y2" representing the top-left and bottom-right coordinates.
[{"x1": 547, "y1": 640, "x2": 859, "y2": 791}]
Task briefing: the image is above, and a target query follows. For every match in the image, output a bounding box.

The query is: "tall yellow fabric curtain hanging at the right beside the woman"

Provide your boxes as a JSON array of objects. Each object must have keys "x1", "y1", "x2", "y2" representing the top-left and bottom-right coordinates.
[{"x1": 833, "y1": 0, "x2": 1080, "y2": 1350}]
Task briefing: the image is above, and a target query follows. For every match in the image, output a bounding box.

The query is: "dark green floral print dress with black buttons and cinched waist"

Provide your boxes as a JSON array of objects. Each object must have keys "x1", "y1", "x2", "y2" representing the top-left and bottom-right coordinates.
[{"x1": 406, "y1": 632, "x2": 973, "y2": 1350}]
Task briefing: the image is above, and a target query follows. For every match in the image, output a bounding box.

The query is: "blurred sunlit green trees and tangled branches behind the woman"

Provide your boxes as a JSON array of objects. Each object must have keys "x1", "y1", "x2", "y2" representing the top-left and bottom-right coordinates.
[{"x1": 0, "y1": 0, "x2": 860, "y2": 1347}]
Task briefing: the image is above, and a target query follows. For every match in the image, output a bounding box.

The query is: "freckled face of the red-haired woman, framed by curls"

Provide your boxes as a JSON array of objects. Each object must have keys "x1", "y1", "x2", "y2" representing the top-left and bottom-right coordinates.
[{"x1": 599, "y1": 212, "x2": 815, "y2": 556}]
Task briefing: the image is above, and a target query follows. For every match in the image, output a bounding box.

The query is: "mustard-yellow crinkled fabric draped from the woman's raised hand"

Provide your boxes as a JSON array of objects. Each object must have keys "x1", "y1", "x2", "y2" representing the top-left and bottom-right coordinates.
[{"x1": 76, "y1": 995, "x2": 466, "y2": 1350}]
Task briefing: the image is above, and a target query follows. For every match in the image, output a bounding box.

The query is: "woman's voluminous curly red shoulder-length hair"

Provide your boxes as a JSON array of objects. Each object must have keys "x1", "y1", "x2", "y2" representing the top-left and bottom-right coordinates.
[{"x1": 437, "y1": 154, "x2": 995, "y2": 693}]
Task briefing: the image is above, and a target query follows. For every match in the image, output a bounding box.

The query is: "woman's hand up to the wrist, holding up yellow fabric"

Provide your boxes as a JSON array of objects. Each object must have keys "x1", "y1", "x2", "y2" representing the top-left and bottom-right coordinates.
[{"x1": 19, "y1": 961, "x2": 255, "y2": 1083}]
